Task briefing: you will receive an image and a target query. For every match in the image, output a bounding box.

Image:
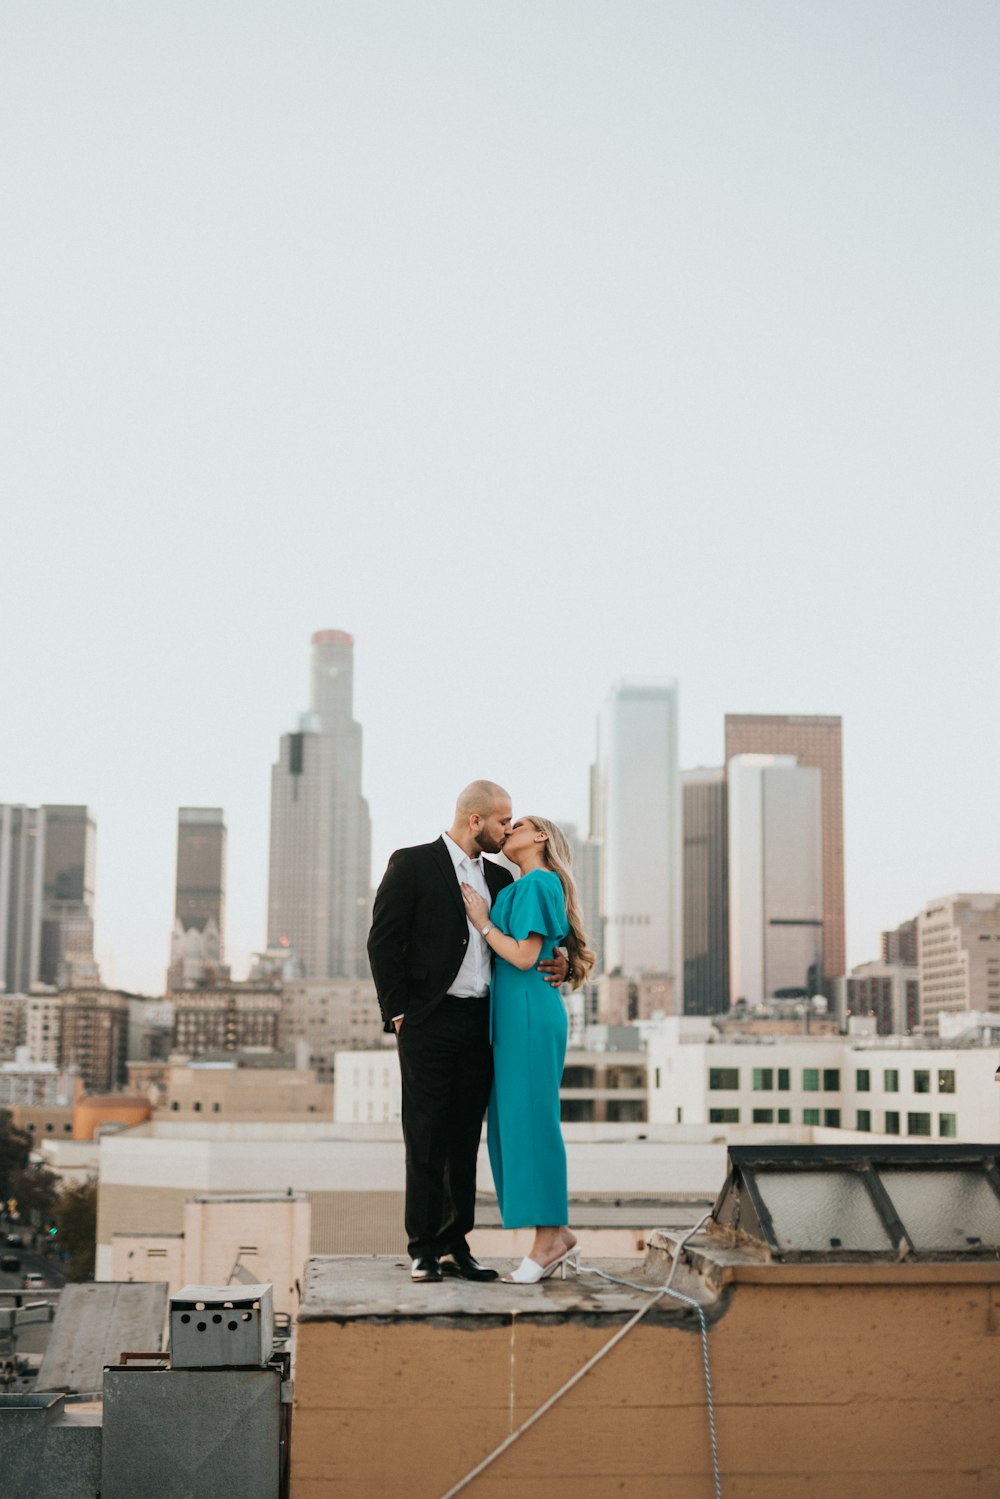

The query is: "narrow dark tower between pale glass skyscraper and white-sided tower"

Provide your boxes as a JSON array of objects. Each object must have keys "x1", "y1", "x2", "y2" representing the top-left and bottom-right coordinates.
[{"x1": 681, "y1": 766, "x2": 729, "y2": 1015}]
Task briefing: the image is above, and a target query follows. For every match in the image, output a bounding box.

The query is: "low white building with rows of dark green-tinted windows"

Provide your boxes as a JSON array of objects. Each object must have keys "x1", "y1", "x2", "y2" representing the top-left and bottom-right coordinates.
[{"x1": 649, "y1": 1016, "x2": 1000, "y2": 1141}]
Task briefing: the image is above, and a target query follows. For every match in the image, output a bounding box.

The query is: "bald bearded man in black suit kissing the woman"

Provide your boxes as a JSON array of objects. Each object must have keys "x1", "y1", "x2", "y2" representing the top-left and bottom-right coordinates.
[{"x1": 367, "y1": 781, "x2": 567, "y2": 1280}]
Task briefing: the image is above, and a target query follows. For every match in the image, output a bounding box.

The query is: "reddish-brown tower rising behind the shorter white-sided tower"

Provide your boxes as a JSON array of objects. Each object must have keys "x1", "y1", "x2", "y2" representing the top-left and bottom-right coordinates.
[{"x1": 726, "y1": 714, "x2": 847, "y2": 992}]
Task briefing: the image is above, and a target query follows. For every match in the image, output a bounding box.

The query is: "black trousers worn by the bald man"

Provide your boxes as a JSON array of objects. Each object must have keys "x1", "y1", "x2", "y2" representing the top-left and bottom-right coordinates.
[{"x1": 397, "y1": 995, "x2": 493, "y2": 1258}]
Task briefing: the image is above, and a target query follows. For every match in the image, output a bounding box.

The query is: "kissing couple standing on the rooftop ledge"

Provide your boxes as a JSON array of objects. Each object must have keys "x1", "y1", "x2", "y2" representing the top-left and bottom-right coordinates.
[{"x1": 367, "y1": 781, "x2": 594, "y2": 1285}]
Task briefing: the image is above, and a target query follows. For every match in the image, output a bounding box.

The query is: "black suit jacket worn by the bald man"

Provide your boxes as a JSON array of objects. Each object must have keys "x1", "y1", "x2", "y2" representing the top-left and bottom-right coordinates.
[{"x1": 367, "y1": 838, "x2": 513, "y2": 1031}]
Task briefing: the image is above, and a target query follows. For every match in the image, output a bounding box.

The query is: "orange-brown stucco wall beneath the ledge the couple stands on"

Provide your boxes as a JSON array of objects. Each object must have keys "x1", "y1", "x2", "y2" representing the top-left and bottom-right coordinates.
[{"x1": 291, "y1": 1267, "x2": 1000, "y2": 1499}]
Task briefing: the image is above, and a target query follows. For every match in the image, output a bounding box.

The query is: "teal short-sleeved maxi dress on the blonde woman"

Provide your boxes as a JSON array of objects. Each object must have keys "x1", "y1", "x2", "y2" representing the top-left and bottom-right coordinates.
[{"x1": 487, "y1": 869, "x2": 570, "y2": 1228}]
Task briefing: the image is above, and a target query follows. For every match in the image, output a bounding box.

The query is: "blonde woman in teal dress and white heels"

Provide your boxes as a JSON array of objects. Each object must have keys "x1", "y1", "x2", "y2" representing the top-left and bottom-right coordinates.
[{"x1": 462, "y1": 817, "x2": 594, "y2": 1285}]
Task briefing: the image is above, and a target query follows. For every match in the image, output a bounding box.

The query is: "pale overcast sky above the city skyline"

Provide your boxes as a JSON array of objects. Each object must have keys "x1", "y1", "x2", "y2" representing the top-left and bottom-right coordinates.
[{"x1": 0, "y1": 0, "x2": 1000, "y2": 992}]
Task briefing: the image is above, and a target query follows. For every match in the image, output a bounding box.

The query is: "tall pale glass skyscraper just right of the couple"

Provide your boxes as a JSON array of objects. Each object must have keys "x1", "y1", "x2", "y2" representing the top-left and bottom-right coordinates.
[{"x1": 595, "y1": 681, "x2": 684, "y2": 1010}]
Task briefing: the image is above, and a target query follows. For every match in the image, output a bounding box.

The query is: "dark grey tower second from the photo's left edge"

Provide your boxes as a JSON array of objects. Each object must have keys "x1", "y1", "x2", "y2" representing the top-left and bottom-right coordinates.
[{"x1": 37, "y1": 803, "x2": 100, "y2": 989}]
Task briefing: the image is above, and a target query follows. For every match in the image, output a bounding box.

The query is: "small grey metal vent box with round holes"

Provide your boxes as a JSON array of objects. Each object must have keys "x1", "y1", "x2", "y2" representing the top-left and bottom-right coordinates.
[{"x1": 169, "y1": 1285, "x2": 274, "y2": 1369}]
